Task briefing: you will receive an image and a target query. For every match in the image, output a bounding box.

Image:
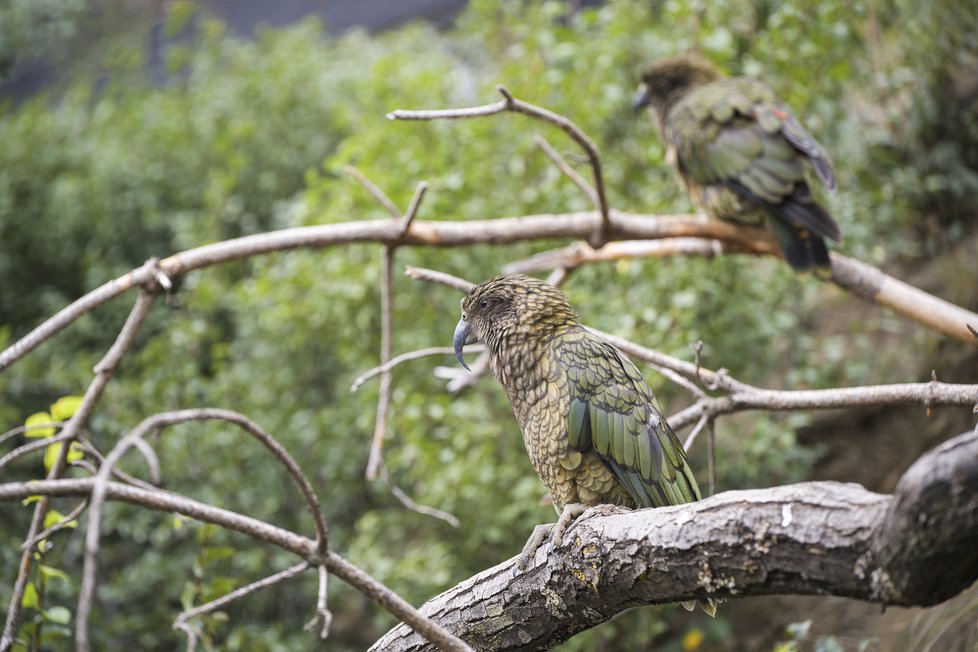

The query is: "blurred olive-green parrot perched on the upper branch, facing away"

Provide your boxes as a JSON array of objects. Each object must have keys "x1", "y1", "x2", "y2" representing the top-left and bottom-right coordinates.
[{"x1": 634, "y1": 55, "x2": 841, "y2": 271}]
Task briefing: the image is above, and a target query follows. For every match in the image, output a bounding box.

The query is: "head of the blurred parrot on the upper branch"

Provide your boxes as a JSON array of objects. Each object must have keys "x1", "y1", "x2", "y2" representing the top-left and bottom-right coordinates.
[{"x1": 633, "y1": 54, "x2": 723, "y2": 124}]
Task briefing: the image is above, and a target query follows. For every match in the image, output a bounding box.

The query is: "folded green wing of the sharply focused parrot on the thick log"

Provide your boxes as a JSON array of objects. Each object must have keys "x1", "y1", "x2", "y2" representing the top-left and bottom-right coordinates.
[{"x1": 560, "y1": 327, "x2": 700, "y2": 507}]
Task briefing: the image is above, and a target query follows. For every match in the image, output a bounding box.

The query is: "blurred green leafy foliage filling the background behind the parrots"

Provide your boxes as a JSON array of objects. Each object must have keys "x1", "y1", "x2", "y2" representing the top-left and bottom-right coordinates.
[{"x1": 0, "y1": 0, "x2": 978, "y2": 650}]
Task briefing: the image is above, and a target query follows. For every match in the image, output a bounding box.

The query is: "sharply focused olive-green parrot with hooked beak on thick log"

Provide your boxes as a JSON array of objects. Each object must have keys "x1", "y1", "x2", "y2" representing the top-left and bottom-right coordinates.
[{"x1": 454, "y1": 275, "x2": 716, "y2": 615}]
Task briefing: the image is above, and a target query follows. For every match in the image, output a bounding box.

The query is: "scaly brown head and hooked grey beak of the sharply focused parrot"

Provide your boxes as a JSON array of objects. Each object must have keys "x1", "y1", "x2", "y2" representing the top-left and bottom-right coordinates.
[{"x1": 454, "y1": 274, "x2": 579, "y2": 369}]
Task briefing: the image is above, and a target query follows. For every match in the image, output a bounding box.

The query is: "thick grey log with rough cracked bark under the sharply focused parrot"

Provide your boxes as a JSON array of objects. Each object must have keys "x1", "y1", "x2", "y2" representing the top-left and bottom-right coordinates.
[{"x1": 371, "y1": 432, "x2": 978, "y2": 651}]
